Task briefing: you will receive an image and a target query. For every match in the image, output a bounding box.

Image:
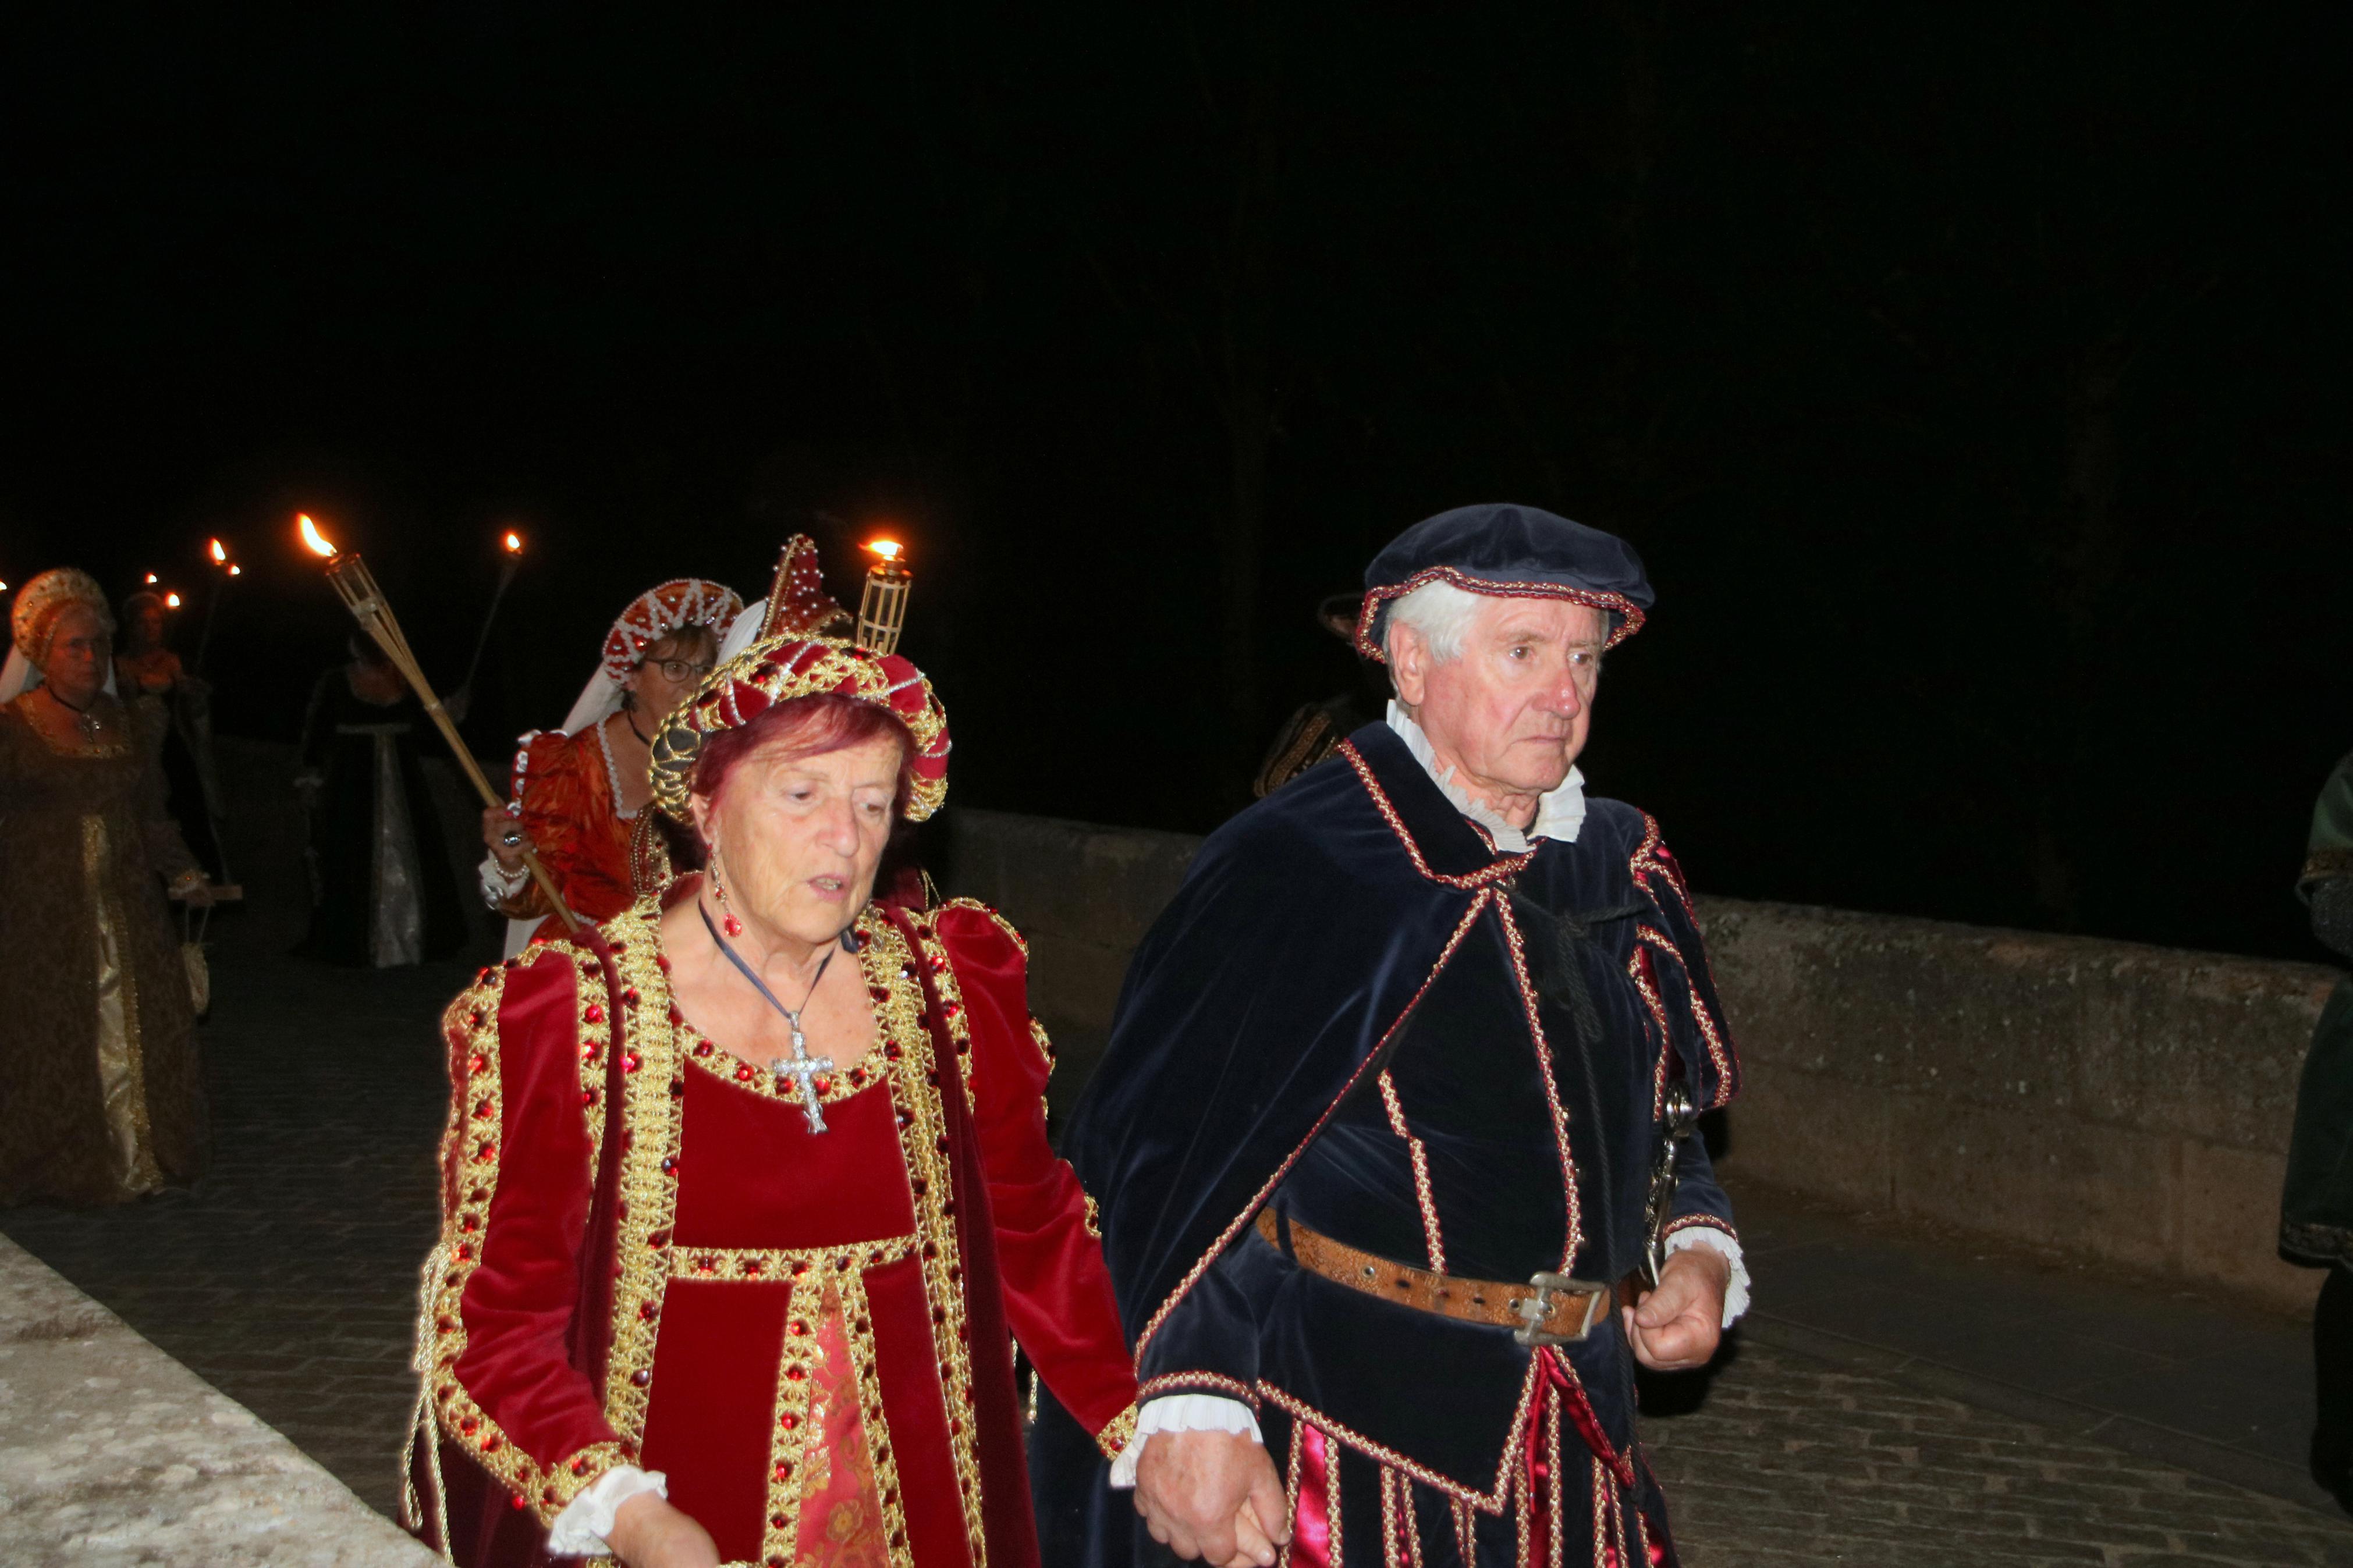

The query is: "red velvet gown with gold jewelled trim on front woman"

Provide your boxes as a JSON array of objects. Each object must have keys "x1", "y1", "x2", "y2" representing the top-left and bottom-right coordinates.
[{"x1": 412, "y1": 901, "x2": 1137, "y2": 1568}]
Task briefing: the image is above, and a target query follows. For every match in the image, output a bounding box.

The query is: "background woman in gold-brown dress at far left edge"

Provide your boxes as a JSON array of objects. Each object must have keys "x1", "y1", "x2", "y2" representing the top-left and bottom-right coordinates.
[{"x1": 0, "y1": 567, "x2": 212, "y2": 1204}]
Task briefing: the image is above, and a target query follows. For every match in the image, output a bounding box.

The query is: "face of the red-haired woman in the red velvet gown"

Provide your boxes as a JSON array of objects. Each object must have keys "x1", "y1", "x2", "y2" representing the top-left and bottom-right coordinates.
[{"x1": 692, "y1": 736, "x2": 906, "y2": 947}]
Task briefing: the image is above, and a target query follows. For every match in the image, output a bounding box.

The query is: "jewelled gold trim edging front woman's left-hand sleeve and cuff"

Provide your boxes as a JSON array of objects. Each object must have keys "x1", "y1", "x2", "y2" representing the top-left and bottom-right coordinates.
[{"x1": 419, "y1": 943, "x2": 636, "y2": 1523}]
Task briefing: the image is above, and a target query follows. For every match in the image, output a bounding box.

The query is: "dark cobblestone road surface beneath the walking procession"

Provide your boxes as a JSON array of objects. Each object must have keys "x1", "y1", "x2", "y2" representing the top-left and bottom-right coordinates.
[{"x1": 0, "y1": 954, "x2": 2353, "y2": 1568}]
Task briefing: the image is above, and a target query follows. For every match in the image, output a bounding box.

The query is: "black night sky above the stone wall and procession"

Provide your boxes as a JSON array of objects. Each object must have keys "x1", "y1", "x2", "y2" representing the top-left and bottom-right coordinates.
[{"x1": 0, "y1": 0, "x2": 2353, "y2": 957}]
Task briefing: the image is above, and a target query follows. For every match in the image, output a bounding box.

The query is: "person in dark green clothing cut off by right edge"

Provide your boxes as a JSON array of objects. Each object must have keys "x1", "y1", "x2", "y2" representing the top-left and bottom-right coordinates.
[{"x1": 2280, "y1": 757, "x2": 2353, "y2": 1512}]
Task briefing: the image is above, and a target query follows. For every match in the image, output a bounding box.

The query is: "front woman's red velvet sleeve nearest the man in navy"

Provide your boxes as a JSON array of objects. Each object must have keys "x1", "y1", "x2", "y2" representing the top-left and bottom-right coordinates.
[{"x1": 934, "y1": 901, "x2": 1137, "y2": 1457}]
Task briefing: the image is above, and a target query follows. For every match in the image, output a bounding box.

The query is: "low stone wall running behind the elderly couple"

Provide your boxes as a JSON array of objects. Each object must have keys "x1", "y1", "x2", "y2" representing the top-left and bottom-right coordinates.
[{"x1": 941, "y1": 809, "x2": 2337, "y2": 1307}]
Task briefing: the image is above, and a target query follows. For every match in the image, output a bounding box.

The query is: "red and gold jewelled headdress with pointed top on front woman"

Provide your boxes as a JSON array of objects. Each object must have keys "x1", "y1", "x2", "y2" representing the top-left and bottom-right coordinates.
[{"x1": 650, "y1": 534, "x2": 948, "y2": 823}]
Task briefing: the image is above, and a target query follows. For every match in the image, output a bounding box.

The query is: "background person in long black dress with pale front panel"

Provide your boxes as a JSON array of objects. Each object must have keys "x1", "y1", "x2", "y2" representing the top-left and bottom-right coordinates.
[{"x1": 294, "y1": 637, "x2": 466, "y2": 969}]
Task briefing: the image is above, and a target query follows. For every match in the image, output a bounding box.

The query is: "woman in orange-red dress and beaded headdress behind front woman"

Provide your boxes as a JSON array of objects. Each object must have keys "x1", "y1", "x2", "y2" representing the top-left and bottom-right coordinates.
[{"x1": 480, "y1": 578, "x2": 744, "y2": 957}]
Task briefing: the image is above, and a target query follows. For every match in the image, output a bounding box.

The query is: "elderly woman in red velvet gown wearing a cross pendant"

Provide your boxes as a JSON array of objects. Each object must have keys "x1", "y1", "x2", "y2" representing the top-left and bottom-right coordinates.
[{"x1": 409, "y1": 635, "x2": 1137, "y2": 1568}]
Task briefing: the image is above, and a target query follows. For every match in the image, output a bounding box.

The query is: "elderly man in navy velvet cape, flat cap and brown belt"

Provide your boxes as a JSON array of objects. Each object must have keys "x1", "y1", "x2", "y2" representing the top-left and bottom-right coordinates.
[{"x1": 1033, "y1": 506, "x2": 1748, "y2": 1568}]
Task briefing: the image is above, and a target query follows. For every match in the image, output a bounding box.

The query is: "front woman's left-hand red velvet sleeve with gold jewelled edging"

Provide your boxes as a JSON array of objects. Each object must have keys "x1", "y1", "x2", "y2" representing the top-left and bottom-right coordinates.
[{"x1": 428, "y1": 945, "x2": 626, "y2": 1523}]
